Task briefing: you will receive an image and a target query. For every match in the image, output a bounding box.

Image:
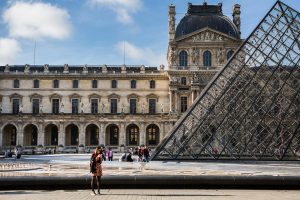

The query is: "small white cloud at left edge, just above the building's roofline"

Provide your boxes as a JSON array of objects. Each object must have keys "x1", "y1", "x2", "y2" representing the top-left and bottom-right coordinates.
[{"x1": 0, "y1": 38, "x2": 21, "y2": 65}]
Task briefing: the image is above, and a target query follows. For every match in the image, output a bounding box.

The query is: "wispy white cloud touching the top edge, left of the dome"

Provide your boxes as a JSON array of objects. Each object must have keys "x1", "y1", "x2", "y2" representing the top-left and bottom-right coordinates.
[{"x1": 88, "y1": 0, "x2": 142, "y2": 24}]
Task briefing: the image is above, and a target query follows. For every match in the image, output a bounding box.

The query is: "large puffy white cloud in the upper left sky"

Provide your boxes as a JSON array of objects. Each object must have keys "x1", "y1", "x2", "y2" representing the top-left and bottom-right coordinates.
[{"x1": 2, "y1": 1, "x2": 71, "y2": 39}]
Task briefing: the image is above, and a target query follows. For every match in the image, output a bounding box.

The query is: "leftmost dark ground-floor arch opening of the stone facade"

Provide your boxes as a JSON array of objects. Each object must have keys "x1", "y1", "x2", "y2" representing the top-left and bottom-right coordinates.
[{"x1": 2, "y1": 123, "x2": 18, "y2": 147}]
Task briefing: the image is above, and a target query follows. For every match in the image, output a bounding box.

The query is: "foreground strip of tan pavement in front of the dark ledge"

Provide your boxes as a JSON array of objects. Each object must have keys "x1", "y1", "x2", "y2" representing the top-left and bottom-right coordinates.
[{"x1": 0, "y1": 189, "x2": 300, "y2": 200}]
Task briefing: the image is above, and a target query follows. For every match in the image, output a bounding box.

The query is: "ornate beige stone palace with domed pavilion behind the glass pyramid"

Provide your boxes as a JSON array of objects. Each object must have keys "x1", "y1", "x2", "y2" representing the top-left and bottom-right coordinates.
[{"x1": 0, "y1": 3, "x2": 242, "y2": 151}]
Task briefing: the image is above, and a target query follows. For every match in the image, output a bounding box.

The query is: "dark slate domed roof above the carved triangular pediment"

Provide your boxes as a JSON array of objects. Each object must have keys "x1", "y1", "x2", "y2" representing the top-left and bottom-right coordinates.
[{"x1": 175, "y1": 3, "x2": 239, "y2": 39}]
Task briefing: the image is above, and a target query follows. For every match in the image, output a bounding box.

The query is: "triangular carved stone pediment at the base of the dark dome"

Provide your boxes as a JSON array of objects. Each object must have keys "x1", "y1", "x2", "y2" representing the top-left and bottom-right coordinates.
[{"x1": 176, "y1": 28, "x2": 239, "y2": 42}]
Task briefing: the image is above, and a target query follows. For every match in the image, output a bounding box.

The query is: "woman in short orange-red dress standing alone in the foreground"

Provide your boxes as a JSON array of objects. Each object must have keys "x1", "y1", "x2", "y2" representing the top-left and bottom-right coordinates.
[{"x1": 90, "y1": 147, "x2": 103, "y2": 195}]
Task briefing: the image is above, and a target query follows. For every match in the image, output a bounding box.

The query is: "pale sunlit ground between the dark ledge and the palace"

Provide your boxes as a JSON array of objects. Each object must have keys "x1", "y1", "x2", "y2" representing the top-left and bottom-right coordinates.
[{"x1": 0, "y1": 154, "x2": 300, "y2": 177}]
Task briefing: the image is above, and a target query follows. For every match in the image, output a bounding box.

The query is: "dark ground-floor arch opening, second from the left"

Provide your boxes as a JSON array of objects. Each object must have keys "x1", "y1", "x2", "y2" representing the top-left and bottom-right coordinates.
[{"x1": 23, "y1": 123, "x2": 39, "y2": 146}]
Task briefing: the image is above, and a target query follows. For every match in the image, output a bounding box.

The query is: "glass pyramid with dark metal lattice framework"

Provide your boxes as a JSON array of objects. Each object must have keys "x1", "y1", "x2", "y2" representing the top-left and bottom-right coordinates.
[{"x1": 151, "y1": 1, "x2": 300, "y2": 160}]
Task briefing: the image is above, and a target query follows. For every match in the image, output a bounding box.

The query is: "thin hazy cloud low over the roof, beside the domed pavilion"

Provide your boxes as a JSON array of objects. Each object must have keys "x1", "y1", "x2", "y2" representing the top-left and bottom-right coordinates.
[{"x1": 116, "y1": 41, "x2": 166, "y2": 66}]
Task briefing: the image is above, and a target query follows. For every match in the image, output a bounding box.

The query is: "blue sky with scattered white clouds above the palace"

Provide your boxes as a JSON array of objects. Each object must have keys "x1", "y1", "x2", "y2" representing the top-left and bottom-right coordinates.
[{"x1": 0, "y1": 0, "x2": 300, "y2": 67}]
